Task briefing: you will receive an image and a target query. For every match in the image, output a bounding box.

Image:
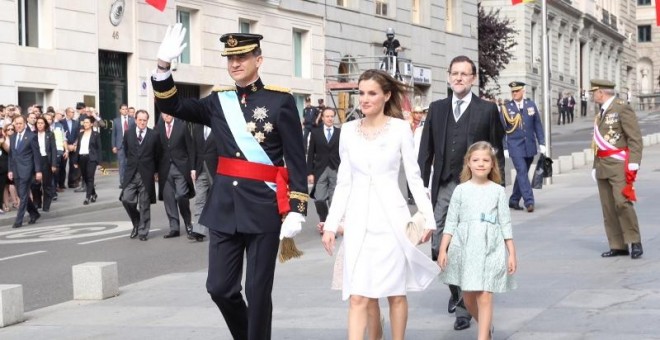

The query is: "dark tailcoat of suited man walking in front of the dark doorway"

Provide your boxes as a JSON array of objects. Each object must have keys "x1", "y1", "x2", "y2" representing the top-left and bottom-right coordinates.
[{"x1": 120, "y1": 126, "x2": 161, "y2": 204}]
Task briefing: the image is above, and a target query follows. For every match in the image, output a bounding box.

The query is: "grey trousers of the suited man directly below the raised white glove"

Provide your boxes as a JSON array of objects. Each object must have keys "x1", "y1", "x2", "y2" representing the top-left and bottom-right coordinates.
[{"x1": 163, "y1": 163, "x2": 192, "y2": 232}]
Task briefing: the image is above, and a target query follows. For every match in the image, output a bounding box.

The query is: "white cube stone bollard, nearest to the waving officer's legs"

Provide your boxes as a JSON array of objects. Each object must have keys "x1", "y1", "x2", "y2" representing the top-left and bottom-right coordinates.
[{"x1": 71, "y1": 262, "x2": 119, "y2": 300}]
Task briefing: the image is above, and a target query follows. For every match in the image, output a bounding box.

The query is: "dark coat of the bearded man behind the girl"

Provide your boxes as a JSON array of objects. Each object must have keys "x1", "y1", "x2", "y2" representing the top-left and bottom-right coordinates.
[{"x1": 419, "y1": 94, "x2": 504, "y2": 205}]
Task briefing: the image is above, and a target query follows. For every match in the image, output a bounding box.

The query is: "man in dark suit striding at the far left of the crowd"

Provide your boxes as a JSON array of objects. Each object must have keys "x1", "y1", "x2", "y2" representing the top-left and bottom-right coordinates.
[{"x1": 7, "y1": 116, "x2": 41, "y2": 228}]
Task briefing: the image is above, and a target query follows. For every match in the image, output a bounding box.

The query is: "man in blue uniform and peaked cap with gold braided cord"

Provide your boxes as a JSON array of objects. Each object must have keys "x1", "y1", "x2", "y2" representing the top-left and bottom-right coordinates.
[{"x1": 501, "y1": 81, "x2": 546, "y2": 212}]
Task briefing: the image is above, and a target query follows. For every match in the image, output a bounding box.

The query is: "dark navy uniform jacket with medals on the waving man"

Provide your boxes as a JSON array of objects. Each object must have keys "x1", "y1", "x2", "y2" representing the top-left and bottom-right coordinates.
[{"x1": 152, "y1": 77, "x2": 309, "y2": 234}]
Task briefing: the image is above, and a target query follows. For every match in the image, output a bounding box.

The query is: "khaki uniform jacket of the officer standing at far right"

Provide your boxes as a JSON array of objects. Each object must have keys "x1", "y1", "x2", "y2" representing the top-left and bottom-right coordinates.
[{"x1": 594, "y1": 99, "x2": 644, "y2": 179}]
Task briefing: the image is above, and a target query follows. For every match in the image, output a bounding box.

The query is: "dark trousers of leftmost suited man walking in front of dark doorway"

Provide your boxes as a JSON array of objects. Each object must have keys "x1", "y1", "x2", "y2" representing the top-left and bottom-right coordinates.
[{"x1": 120, "y1": 172, "x2": 151, "y2": 236}]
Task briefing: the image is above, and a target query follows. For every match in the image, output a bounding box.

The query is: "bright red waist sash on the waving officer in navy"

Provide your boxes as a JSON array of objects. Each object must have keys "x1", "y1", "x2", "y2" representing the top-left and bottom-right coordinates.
[{"x1": 216, "y1": 157, "x2": 291, "y2": 215}]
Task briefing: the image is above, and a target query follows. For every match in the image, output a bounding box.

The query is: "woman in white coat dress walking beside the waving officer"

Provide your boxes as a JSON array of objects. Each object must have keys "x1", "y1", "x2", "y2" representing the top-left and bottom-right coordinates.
[{"x1": 323, "y1": 70, "x2": 439, "y2": 340}]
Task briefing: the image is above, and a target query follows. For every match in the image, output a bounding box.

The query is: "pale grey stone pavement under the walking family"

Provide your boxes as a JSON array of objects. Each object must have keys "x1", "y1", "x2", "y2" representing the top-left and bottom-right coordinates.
[{"x1": 0, "y1": 135, "x2": 660, "y2": 340}]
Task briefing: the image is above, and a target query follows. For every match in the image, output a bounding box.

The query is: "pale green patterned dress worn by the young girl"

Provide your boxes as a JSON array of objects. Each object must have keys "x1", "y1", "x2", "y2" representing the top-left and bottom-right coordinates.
[{"x1": 440, "y1": 181, "x2": 516, "y2": 293}]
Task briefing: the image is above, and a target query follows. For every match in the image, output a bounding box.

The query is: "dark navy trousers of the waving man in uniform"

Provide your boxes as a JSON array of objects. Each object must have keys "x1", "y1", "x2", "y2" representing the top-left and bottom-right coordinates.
[{"x1": 206, "y1": 229, "x2": 279, "y2": 340}]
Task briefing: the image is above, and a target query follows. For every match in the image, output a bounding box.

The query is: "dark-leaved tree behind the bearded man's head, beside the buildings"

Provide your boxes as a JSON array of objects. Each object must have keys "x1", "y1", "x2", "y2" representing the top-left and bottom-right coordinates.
[{"x1": 477, "y1": 3, "x2": 518, "y2": 96}]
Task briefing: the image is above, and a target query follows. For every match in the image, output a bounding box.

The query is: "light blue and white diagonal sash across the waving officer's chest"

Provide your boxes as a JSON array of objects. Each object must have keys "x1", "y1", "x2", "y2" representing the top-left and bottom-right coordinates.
[{"x1": 218, "y1": 91, "x2": 277, "y2": 190}]
